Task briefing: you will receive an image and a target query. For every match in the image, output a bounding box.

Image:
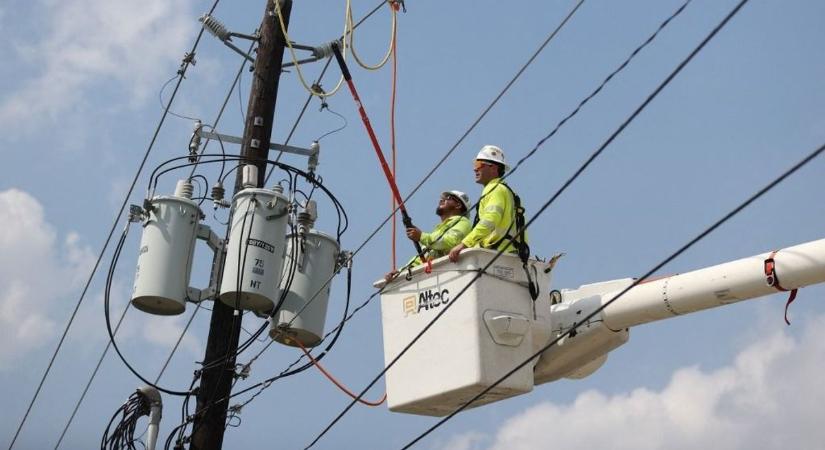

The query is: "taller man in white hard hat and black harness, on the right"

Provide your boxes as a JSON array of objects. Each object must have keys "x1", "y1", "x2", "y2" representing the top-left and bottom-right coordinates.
[{"x1": 449, "y1": 145, "x2": 530, "y2": 262}]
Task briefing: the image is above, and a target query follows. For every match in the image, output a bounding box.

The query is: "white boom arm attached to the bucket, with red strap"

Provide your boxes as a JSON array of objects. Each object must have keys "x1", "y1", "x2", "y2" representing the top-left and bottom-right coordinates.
[{"x1": 533, "y1": 239, "x2": 825, "y2": 385}]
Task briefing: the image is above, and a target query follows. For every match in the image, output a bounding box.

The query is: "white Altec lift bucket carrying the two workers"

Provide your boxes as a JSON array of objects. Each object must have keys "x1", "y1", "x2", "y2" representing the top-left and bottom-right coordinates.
[{"x1": 374, "y1": 249, "x2": 551, "y2": 416}]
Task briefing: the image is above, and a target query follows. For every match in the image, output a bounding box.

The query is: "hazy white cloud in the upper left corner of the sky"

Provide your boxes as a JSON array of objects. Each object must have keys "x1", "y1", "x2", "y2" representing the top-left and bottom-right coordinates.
[{"x1": 0, "y1": 0, "x2": 197, "y2": 129}]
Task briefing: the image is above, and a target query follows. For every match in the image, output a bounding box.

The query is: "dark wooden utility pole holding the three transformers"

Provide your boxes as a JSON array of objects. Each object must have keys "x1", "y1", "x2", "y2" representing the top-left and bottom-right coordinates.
[{"x1": 190, "y1": 0, "x2": 292, "y2": 450}]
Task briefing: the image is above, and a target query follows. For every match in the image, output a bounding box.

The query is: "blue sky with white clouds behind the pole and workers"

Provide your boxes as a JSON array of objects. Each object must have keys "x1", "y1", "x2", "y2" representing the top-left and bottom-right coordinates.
[{"x1": 0, "y1": 0, "x2": 825, "y2": 450}]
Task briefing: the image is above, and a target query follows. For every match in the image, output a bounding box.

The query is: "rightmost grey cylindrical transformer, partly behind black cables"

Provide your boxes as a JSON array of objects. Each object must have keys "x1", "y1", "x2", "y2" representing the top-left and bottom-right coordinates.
[{"x1": 269, "y1": 230, "x2": 339, "y2": 347}]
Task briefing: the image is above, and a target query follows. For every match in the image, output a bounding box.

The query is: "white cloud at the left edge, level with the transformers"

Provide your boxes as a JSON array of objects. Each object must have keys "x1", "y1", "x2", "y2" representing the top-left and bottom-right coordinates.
[{"x1": 0, "y1": 189, "x2": 92, "y2": 370}]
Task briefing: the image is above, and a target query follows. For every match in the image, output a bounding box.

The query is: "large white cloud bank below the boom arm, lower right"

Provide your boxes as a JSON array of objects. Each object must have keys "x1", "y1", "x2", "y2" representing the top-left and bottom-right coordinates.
[{"x1": 439, "y1": 316, "x2": 825, "y2": 450}]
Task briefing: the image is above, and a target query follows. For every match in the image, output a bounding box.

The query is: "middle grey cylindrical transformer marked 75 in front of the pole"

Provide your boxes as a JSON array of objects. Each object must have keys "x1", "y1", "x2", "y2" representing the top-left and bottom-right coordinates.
[{"x1": 220, "y1": 188, "x2": 289, "y2": 313}]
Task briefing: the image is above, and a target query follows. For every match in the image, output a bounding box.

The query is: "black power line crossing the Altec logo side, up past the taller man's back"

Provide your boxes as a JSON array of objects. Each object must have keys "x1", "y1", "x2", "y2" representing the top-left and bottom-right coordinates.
[{"x1": 306, "y1": 0, "x2": 748, "y2": 442}]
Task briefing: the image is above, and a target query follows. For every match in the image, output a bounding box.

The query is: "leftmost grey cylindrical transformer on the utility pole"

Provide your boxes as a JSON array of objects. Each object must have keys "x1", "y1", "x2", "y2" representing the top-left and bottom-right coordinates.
[{"x1": 132, "y1": 196, "x2": 202, "y2": 316}]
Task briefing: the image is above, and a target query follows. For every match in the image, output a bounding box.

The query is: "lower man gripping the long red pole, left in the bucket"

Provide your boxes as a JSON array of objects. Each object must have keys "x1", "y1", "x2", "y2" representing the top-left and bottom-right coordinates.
[{"x1": 384, "y1": 191, "x2": 472, "y2": 281}]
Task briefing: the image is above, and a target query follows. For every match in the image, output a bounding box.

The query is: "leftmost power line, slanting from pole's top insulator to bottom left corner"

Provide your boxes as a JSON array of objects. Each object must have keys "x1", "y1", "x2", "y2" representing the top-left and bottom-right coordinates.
[{"x1": 9, "y1": 0, "x2": 220, "y2": 450}]
